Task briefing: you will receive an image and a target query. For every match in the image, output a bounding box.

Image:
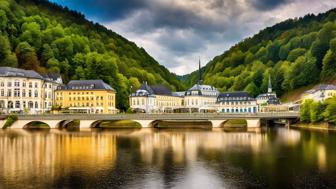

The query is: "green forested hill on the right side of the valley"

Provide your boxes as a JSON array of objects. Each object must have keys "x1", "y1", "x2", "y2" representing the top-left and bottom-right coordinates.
[{"x1": 183, "y1": 9, "x2": 336, "y2": 96}]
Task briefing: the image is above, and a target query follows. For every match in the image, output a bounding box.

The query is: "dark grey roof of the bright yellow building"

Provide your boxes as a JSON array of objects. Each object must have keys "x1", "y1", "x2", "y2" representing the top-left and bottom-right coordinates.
[{"x1": 60, "y1": 80, "x2": 114, "y2": 91}]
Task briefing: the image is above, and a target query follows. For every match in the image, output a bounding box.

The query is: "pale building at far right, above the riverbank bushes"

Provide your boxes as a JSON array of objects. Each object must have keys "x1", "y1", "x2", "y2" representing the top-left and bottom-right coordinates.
[{"x1": 301, "y1": 84, "x2": 336, "y2": 101}]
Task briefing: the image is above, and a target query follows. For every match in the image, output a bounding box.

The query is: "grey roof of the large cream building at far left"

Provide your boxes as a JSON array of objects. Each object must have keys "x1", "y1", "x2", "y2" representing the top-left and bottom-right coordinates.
[{"x1": 0, "y1": 67, "x2": 44, "y2": 79}]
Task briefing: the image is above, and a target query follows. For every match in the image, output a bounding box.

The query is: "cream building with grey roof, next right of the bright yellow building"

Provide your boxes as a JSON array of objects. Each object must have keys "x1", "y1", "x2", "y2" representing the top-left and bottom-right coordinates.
[{"x1": 129, "y1": 82, "x2": 183, "y2": 113}]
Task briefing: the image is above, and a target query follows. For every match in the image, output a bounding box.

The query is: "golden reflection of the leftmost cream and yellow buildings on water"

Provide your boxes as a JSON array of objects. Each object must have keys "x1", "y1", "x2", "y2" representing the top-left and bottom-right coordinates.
[{"x1": 0, "y1": 130, "x2": 116, "y2": 179}]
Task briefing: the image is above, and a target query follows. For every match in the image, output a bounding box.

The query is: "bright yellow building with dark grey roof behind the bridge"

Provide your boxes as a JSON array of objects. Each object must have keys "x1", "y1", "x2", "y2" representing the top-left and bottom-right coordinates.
[{"x1": 55, "y1": 80, "x2": 118, "y2": 114}]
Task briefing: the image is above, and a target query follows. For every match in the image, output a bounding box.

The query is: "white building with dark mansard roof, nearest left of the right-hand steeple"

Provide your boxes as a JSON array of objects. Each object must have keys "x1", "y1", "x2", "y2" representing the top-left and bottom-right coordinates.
[{"x1": 217, "y1": 92, "x2": 258, "y2": 113}]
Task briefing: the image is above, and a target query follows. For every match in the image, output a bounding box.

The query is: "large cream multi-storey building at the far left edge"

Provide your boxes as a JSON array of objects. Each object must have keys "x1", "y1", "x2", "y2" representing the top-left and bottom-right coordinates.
[{"x1": 0, "y1": 67, "x2": 62, "y2": 114}]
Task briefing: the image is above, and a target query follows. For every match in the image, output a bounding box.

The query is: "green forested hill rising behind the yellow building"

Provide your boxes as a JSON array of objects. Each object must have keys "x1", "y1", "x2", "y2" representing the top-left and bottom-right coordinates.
[{"x1": 0, "y1": 0, "x2": 183, "y2": 109}]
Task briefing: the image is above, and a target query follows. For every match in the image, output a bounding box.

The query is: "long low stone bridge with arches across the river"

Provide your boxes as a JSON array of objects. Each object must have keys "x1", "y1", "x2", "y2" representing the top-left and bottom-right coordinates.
[{"x1": 0, "y1": 112, "x2": 299, "y2": 128}]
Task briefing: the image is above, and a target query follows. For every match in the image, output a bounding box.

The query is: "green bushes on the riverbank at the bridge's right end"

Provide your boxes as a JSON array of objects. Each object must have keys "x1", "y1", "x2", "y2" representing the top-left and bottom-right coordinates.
[{"x1": 300, "y1": 97, "x2": 336, "y2": 128}]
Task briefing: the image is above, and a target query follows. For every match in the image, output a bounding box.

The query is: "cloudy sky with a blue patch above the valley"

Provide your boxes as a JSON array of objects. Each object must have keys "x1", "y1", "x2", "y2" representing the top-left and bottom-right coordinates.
[{"x1": 51, "y1": 0, "x2": 336, "y2": 75}]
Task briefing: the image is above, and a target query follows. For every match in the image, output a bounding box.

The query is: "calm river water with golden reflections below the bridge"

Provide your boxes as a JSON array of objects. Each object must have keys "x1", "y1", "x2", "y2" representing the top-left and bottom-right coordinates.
[{"x1": 0, "y1": 128, "x2": 336, "y2": 189}]
